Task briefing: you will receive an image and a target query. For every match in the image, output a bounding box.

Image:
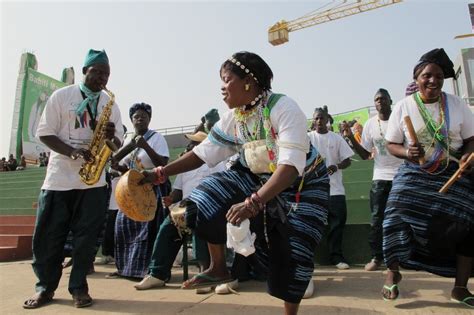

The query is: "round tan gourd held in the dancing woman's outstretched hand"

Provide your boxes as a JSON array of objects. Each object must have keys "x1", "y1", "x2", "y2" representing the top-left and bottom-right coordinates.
[{"x1": 115, "y1": 170, "x2": 157, "y2": 222}]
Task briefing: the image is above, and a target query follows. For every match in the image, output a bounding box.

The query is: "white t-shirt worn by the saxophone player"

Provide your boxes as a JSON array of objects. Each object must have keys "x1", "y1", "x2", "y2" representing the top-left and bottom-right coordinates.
[{"x1": 36, "y1": 85, "x2": 123, "y2": 191}]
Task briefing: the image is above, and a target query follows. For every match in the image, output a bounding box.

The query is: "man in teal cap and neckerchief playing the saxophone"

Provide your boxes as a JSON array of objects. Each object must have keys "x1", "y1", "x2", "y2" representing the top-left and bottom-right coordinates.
[{"x1": 23, "y1": 49, "x2": 123, "y2": 308}]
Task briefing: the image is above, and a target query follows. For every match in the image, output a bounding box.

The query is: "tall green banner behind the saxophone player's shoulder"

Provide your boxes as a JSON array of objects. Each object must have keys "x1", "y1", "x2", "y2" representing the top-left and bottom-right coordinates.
[{"x1": 21, "y1": 68, "x2": 67, "y2": 160}]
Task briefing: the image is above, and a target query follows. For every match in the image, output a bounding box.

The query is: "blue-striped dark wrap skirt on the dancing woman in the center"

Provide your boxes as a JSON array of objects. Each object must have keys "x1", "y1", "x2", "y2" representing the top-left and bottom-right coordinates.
[{"x1": 186, "y1": 154, "x2": 329, "y2": 303}]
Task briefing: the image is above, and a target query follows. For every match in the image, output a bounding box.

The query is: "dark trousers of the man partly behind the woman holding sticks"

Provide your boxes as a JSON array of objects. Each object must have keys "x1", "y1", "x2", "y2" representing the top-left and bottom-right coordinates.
[{"x1": 369, "y1": 180, "x2": 392, "y2": 261}]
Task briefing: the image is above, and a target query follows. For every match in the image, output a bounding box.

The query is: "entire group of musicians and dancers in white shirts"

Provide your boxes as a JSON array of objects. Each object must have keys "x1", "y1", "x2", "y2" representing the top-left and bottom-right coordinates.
[{"x1": 23, "y1": 49, "x2": 474, "y2": 314}]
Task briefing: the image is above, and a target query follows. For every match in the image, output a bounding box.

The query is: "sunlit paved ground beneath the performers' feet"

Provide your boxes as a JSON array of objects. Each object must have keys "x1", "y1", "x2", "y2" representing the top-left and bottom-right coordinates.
[{"x1": 0, "y1": 261, "x2": 474, "y2": 315}]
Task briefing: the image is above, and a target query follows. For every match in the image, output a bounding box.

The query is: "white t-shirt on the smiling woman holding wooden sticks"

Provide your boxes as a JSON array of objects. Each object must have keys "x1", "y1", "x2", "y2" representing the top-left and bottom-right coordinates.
[{"x1": 385, "y1": 93, "x2": 474, "y2": 159}]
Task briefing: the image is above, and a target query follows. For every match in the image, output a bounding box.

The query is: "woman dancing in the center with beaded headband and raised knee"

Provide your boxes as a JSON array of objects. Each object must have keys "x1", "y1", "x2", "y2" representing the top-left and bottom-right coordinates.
[{"x1": 140, "y1": 52, "x2": 329, "y2": 314}]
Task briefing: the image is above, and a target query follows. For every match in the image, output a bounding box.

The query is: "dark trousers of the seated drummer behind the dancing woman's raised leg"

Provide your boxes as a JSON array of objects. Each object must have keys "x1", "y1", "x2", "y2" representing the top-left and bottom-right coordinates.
[{"x1": 148, "y1": 216, "x2": 209, "y2": 281}]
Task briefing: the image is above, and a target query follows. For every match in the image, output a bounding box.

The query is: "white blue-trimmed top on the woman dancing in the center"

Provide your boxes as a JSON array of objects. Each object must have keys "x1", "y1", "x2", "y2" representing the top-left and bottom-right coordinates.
[{"x1": 193, "y1": 96, "x2": 309, "y2": 175}]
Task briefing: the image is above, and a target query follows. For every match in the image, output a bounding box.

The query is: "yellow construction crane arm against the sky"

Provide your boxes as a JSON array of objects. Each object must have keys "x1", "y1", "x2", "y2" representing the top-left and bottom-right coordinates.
[{"x1": 268, "y1": 0, "x2": 402, "y2": 46}]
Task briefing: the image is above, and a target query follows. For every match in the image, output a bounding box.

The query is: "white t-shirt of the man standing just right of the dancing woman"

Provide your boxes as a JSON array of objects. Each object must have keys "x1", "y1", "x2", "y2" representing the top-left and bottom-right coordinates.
[{"x1": 308, "y1": 131, "x2": 354, "y2": 196}]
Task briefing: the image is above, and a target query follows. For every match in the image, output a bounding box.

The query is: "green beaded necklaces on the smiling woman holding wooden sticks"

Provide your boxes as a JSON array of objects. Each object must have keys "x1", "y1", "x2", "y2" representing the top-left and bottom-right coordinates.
[{"x1": 413, "y1": 92, "x2": 450, "y2": 175}]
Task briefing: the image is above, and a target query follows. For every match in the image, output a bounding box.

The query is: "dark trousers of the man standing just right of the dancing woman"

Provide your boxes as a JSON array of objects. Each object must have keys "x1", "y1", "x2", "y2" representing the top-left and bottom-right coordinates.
[{"x1": 328, "y1": 195, "x2": 347, "y2": 265}]
